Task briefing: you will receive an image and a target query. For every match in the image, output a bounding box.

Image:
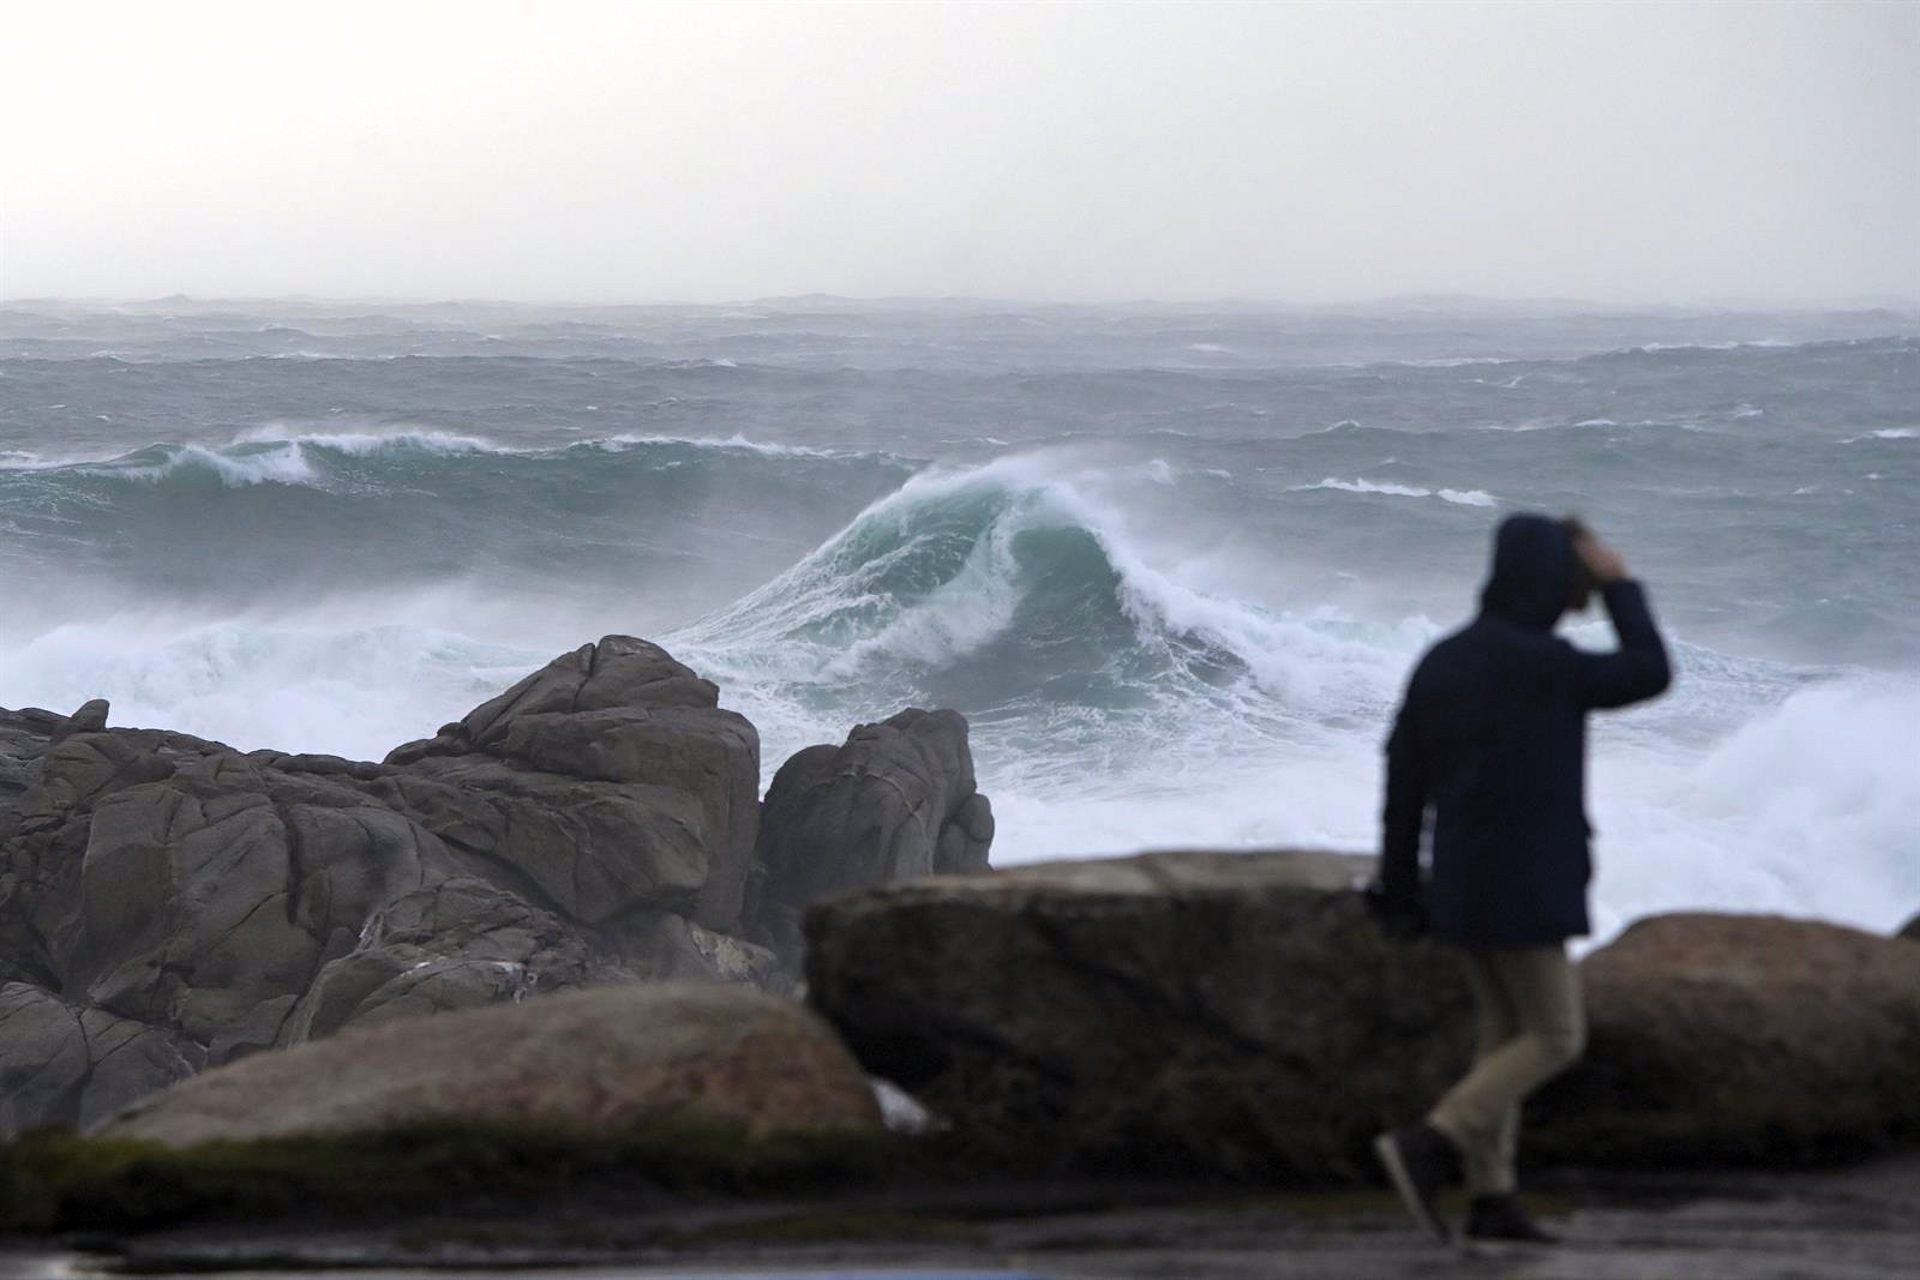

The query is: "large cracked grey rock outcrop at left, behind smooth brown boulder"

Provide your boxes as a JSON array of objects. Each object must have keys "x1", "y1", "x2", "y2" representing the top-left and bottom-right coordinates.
[{"x1": 0, "y1": 635, "x2": 985, "y2": 1136}]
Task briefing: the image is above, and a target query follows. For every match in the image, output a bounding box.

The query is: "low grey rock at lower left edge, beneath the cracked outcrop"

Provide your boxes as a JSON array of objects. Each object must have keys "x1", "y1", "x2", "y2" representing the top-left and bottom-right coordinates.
[{"x1": 0, "y1": 983, "x2": 204, "y2": 1140}]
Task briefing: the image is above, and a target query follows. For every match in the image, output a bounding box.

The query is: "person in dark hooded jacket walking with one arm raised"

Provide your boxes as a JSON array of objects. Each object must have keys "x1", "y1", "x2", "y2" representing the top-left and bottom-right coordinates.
[{"x1": 1369, "y1": 514, "x2": 1672, "y2": 1244}]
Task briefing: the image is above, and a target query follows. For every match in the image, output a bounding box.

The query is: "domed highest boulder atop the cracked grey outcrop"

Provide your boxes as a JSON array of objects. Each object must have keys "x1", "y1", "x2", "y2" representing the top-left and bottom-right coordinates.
[{"x1": 384, "y1": 635, "x2": 760, "y2": 931}]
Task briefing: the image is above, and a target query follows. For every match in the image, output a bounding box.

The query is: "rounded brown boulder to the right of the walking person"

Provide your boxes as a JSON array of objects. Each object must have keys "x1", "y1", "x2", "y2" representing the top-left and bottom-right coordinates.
[{"x1": 1526, "y1": 913, "x2": 1920, "y2": 1167}]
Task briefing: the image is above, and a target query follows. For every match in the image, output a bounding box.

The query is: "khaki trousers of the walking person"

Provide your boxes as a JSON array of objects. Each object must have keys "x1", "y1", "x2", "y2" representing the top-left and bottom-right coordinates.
[{"x1": 1427, "y1": 946, "x2": 1586, "y2": 1196}]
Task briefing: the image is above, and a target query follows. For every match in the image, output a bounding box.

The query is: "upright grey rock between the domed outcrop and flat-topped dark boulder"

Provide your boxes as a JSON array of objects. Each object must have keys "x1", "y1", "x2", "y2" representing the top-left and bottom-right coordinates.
[{"x1": 749, "y1": 708, "x2": 993, "y2": 956}]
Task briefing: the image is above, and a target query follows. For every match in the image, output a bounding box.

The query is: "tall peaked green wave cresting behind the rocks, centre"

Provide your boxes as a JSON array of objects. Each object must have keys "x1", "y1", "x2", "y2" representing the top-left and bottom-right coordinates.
[{"x1": 672, "y1": 459, "x2": 1436, "y2": 722}]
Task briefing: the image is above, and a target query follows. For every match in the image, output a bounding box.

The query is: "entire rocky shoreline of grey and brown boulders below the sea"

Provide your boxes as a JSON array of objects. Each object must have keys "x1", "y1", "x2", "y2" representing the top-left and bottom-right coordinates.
[{"x1": 0, "y1": 637, "x2": 1920, "y2": 1276}]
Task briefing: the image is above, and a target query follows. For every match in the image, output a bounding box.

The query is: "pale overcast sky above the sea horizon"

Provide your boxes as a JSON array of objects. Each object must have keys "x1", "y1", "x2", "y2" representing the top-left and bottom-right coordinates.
[{"x1": 0, "y1": 0, "x2": 1920, "y2": 301}]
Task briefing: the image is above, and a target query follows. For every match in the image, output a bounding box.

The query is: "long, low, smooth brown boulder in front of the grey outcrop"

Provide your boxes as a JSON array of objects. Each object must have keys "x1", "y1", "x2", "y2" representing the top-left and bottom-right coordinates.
[{"x1": 100, "y1": 983, "x2": 879, "y2": 1146}]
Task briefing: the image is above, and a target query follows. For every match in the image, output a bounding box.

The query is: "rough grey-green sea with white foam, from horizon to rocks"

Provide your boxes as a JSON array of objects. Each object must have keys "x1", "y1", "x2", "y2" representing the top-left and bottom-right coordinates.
[{"x1": 0, "y1": 297, "x2": 1920, "y2": 936}]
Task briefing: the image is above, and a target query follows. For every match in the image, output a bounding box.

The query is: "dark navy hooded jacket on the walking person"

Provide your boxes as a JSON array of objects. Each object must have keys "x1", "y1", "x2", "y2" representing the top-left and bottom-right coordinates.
[{"x1": 1380, "y1": 516, "x2": 1670, "y2": 948}]
